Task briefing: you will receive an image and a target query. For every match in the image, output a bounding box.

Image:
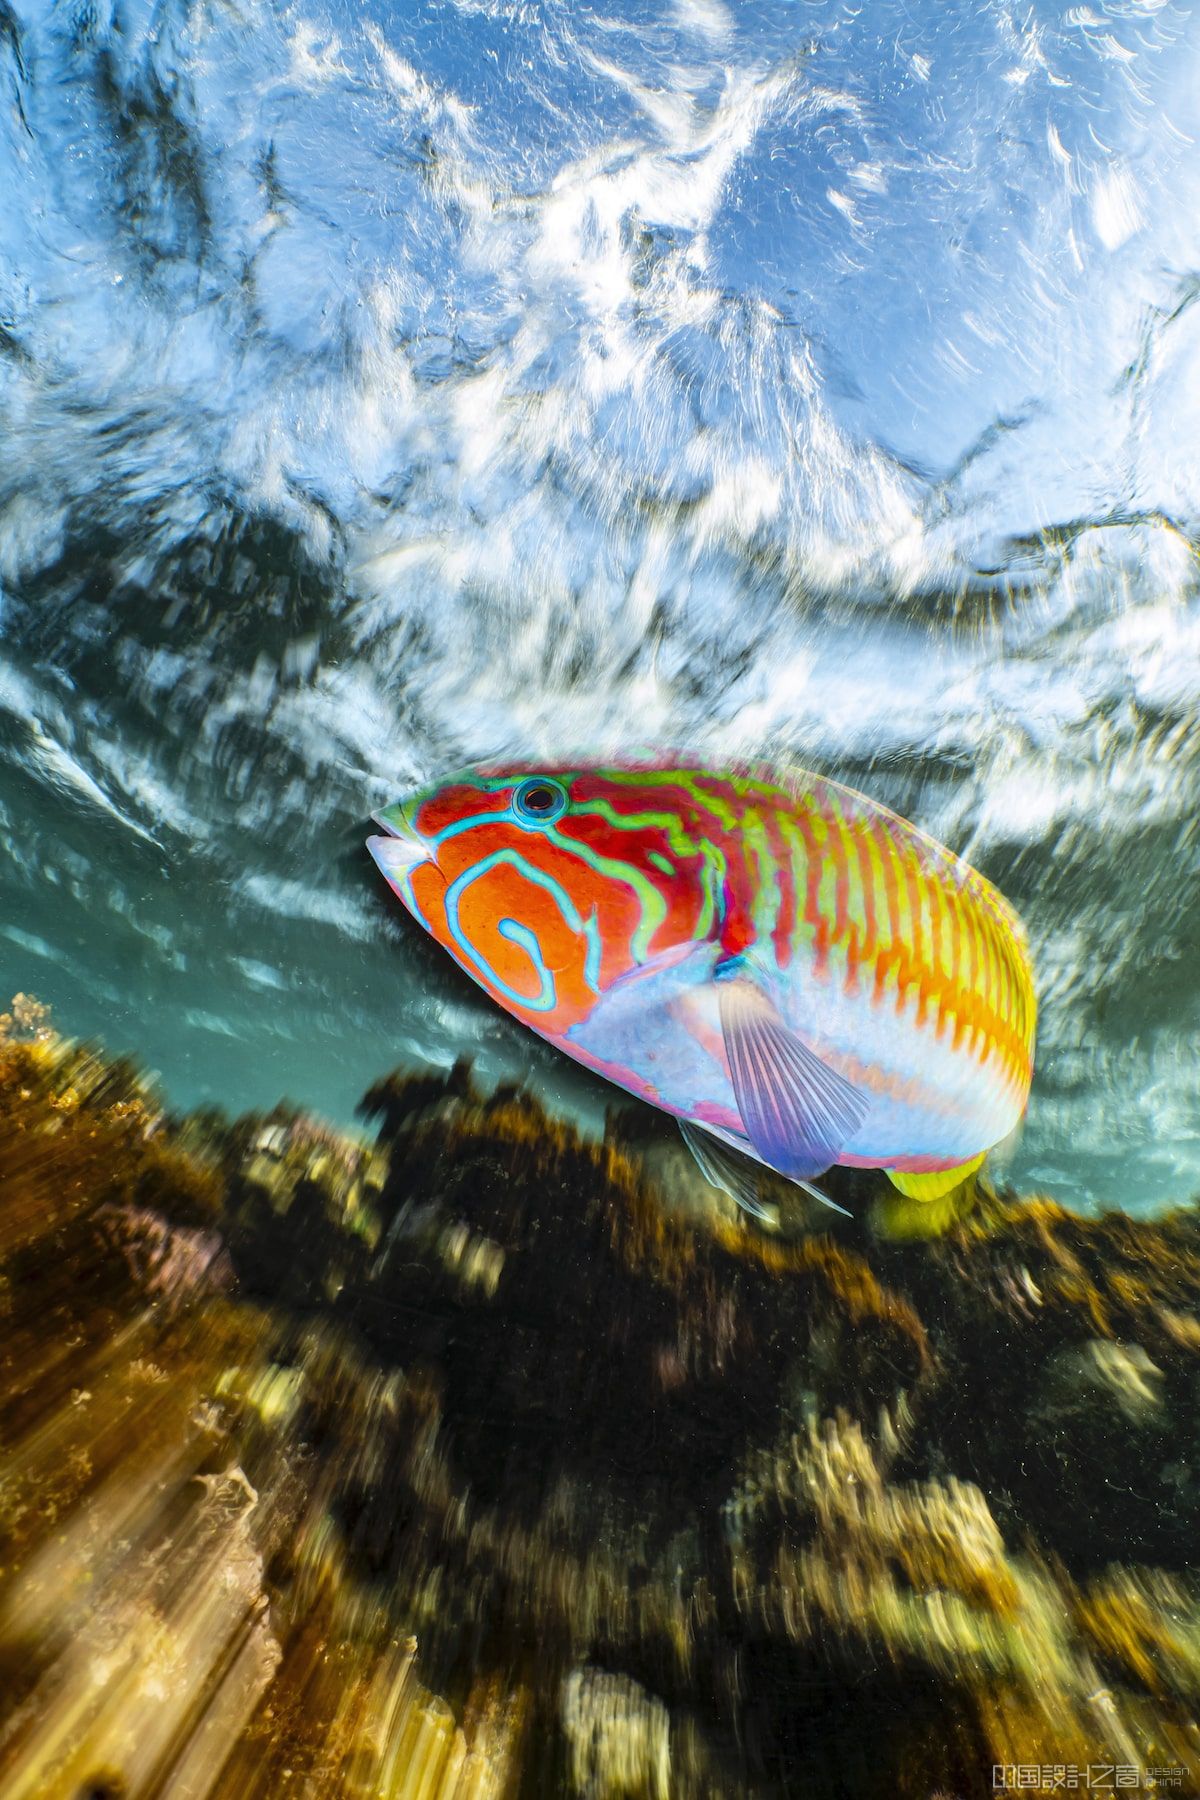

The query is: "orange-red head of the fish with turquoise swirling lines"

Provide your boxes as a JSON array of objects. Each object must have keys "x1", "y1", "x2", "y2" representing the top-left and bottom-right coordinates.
[{"x1": 369, "y1": 769, "x2": 714, "y2": 1037}]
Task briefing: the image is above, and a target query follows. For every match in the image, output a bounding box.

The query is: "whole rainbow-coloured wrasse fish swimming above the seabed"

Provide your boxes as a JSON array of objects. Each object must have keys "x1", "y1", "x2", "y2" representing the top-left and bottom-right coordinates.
[{"x1": 369, "y1": 767, "x2": 1036, "y2": 1211}]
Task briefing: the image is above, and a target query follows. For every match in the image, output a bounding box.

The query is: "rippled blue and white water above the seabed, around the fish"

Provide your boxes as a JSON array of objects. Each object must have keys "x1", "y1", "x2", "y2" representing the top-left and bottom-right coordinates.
[{"x1": 0, "y1": 0, "x2": 1200, "y2": 1210}]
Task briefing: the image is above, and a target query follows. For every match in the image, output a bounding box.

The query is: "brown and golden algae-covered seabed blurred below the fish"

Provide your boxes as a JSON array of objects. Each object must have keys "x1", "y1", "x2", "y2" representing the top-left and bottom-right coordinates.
[{"x1": 0, "y1": 997, "x2": 1200, "y2": 1800}]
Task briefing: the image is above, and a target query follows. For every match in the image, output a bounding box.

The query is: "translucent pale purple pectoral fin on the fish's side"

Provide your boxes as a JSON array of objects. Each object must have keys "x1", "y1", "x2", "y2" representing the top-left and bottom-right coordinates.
[{"x1": 718, "y1": 976, "x2": 869, "y2": 1181}]
